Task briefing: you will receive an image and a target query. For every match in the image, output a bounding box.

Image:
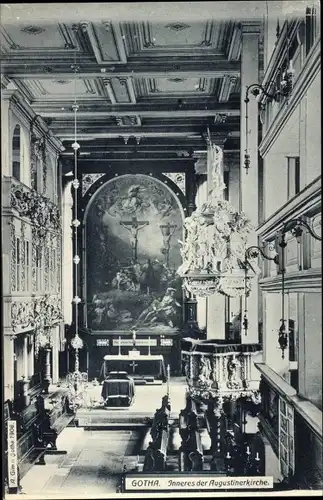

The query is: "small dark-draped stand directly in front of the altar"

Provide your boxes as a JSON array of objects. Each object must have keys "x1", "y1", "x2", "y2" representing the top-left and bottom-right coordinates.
[{"x1": 101, "y1": 372, "x2": 135, "y2": 407}]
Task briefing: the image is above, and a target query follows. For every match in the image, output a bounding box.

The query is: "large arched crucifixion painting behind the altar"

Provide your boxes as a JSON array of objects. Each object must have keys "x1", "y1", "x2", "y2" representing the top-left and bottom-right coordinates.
[{"x1": 86, "y1": 174, "x2": 184, "y2": 334}]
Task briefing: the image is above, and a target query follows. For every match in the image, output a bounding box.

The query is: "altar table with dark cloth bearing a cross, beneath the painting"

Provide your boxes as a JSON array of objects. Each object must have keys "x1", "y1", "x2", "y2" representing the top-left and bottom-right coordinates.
[{"x1": 101, "y1": 351, "x2": 166, "y2": 382}]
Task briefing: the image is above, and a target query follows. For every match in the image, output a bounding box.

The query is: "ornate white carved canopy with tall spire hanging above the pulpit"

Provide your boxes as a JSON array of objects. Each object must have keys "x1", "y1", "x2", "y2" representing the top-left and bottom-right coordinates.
[{"x1": 177, "y1": 136, "x2": 252, "y2": 297}]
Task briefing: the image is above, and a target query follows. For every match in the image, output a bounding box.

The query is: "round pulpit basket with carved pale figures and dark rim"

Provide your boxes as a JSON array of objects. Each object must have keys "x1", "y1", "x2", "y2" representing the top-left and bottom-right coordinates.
[{"x1": 182, "y1": 339, "x2": 262, "y2": 399}]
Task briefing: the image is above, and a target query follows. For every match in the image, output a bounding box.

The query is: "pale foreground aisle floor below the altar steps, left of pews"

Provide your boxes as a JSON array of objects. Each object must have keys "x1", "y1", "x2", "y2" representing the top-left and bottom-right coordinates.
[{"x1": 21, "y1": 428, "x2": 137, "y2": 498}]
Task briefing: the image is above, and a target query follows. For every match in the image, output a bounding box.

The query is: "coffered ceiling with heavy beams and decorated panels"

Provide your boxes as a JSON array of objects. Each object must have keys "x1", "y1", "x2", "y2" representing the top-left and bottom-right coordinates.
[{"x1": 1, "y1": 2, "x2": 266, "y2": 167}]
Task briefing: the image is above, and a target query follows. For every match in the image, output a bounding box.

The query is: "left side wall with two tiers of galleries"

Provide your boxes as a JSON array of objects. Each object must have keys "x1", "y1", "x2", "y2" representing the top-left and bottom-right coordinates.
[{"x1": 1, "y1": 89, "x2": 61, "y2": 399}]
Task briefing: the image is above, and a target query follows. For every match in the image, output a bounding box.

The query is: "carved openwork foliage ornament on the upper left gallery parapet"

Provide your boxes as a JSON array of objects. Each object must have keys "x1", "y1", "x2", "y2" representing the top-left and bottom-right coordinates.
[{"x1": 11, "y1": 185, "x2": 61, "y2": 239}]
